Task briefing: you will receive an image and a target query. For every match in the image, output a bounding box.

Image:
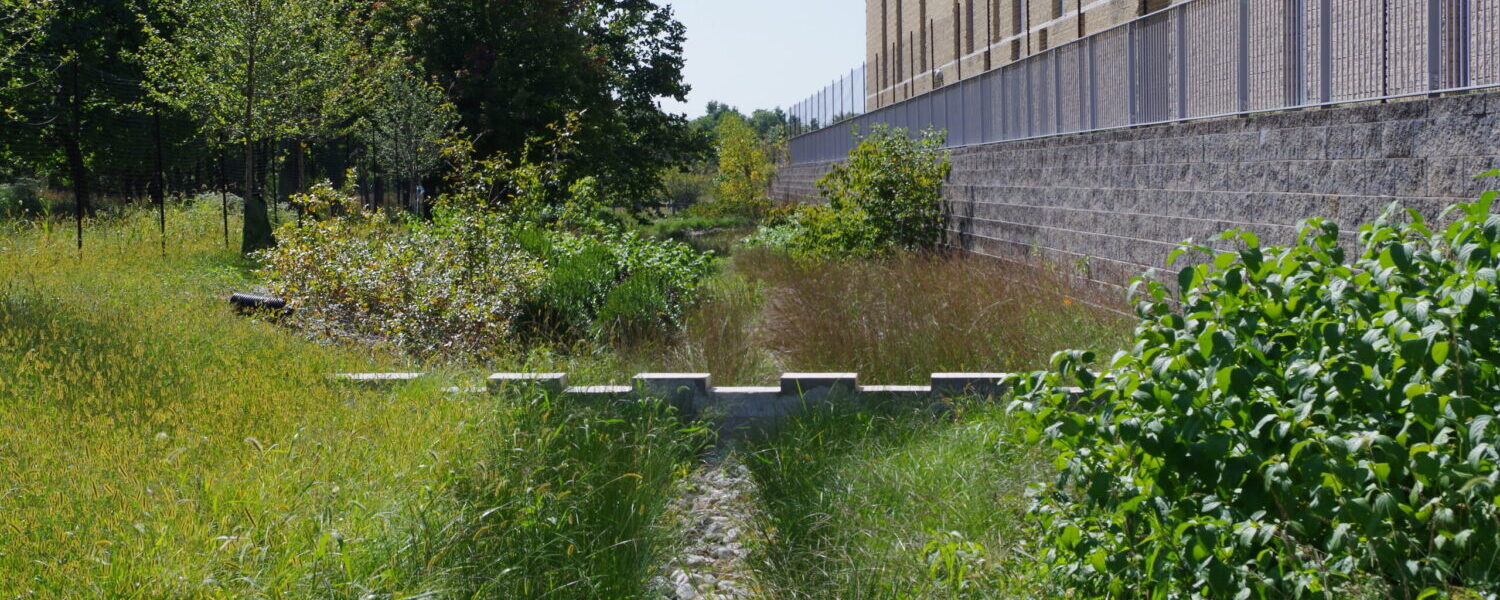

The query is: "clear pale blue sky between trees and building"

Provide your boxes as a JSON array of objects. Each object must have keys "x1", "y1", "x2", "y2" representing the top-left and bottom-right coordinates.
[{"x1": 663, "y1": 0, "x2": 866, "y2": 117}]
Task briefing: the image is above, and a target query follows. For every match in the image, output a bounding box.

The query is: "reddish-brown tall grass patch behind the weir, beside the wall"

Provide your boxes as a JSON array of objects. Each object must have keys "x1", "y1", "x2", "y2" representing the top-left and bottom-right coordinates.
[{"x1": 720, "y1": 249, "x2": 1130, "y2": 384}]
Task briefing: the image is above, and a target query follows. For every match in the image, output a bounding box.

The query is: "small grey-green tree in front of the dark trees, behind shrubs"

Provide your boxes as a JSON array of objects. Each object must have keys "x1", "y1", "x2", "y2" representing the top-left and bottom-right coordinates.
[{"x1": 359, "y1": 69, "x2": 458, "y2": 210}]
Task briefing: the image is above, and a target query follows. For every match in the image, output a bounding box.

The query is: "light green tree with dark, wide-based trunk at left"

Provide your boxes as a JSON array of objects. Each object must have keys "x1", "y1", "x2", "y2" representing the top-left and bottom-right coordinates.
[{"x1": 143, "y1": 0, "x2": 356, "y2": 252}]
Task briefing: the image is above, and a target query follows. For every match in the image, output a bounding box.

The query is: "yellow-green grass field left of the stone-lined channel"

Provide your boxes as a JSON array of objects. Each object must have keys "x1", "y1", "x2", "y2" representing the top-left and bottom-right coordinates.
[{"x1": 0, "y1": 203, "x2": 696, "y2": 599}]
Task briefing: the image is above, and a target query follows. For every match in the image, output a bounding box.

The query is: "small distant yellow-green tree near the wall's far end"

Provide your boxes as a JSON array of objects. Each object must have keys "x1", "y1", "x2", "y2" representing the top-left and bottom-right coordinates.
[{"x1": 714, "y1": 113, "x2": 774, "y2": 216}]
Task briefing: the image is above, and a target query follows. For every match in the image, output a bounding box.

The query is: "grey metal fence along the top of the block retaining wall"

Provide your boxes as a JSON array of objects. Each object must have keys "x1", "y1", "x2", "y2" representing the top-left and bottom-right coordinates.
[{"x1": 791, "y1": 0, "x2": 1500, "y2": 164}]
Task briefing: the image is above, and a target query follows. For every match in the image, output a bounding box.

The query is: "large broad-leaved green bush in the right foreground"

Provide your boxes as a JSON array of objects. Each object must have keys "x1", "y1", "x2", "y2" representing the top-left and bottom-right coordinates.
[{"x1": 1016, "y1": 194, "x2": 1500, "y2": 599}]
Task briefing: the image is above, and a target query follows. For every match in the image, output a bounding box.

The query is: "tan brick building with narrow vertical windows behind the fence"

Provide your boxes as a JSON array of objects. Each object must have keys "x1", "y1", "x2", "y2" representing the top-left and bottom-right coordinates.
[{"x1": 866, "y1": 0, "x2": 1187, "y2": 110}]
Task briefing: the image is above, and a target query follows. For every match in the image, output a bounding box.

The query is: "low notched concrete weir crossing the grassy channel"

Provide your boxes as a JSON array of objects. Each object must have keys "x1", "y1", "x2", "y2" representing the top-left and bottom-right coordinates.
[{"x1": 333, "y1": 374, "x2": 1032, "y2": 431}]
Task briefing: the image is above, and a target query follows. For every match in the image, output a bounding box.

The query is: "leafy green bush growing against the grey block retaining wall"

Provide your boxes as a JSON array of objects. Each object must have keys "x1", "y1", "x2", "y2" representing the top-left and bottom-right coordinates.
[{"x1": 747, "y1": 125, "x2": 951, "y2": 260}]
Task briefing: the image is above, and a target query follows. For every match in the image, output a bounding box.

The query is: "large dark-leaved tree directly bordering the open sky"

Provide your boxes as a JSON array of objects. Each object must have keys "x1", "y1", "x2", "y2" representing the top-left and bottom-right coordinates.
[{"x1": 410, "y1": 0, "x2": 707, "y2": 209}]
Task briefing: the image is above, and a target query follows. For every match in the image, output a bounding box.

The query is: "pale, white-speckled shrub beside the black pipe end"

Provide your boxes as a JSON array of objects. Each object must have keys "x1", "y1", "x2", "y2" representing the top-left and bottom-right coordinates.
[{"x1": 260, "y1": 218, "x2": 546, "y2": 356}]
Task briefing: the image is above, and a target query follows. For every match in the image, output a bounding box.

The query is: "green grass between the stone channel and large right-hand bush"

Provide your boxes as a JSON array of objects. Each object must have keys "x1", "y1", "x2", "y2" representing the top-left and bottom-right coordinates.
[{"x1": 746, "y1": 401, "x2": 1050, "y2": 600}]
